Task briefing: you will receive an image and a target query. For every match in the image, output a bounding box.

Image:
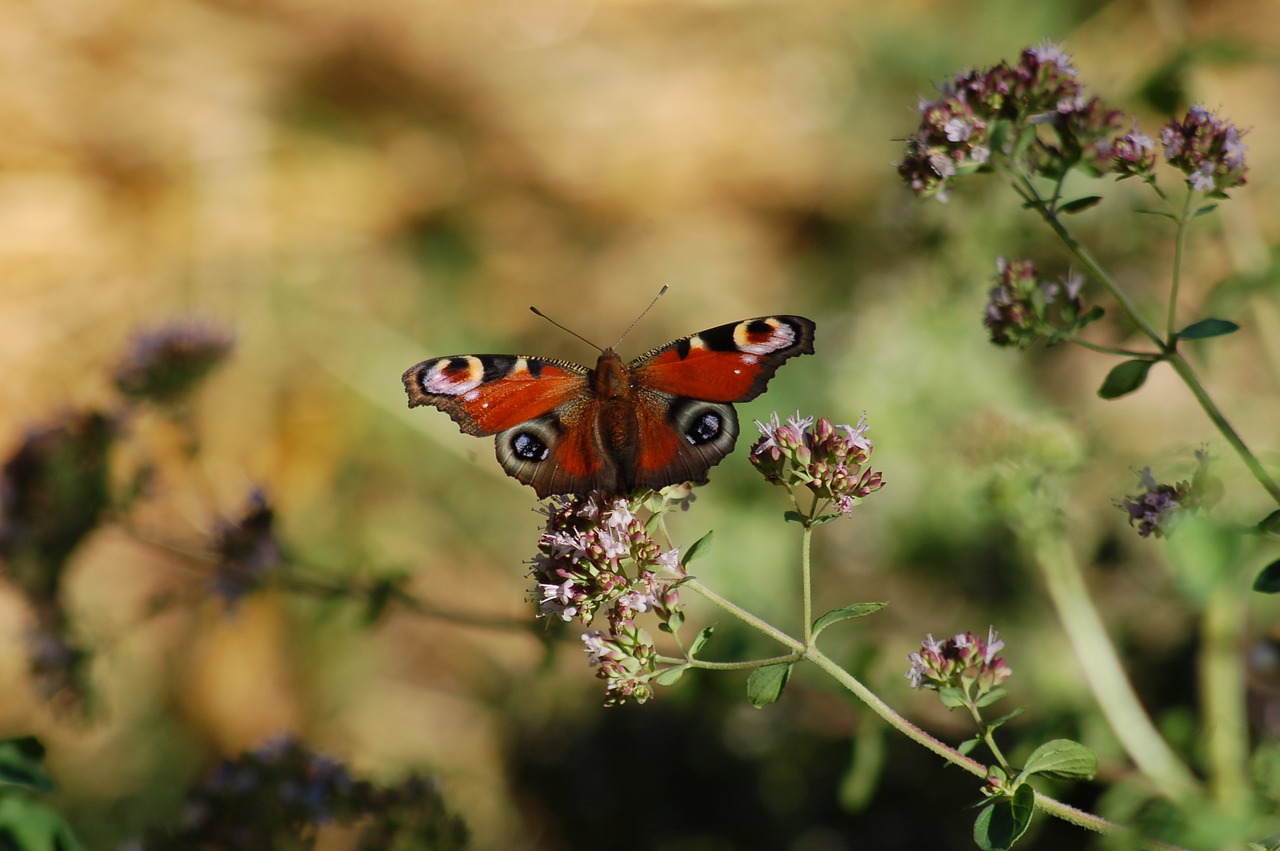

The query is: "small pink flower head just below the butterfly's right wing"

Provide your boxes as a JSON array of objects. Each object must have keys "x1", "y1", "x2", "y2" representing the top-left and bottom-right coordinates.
[{"x1": 750, "y1": 413, "x2": 884, "y2": 514}]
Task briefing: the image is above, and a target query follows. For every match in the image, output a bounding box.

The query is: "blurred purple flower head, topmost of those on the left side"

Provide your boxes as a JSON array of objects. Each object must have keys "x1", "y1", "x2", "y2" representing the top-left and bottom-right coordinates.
[{"x1": 115, "y1": 320, "x2": 232, "y2": 403}]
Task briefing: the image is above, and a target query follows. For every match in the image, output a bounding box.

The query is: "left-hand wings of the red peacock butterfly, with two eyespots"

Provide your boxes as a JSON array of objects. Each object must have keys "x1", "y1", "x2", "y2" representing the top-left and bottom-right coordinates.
[{"x1": 403, "y1": 354, "x2": 620, "y2": 498}]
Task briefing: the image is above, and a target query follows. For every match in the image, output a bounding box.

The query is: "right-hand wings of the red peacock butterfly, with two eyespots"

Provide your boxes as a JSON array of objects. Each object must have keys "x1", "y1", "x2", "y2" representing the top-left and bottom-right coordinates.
[{"x1": 626, "y1": 316, "x2": 814, "y2": 489}]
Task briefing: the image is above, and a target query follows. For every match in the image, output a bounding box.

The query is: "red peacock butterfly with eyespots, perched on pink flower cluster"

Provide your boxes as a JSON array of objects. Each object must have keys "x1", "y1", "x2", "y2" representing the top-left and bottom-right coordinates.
[{"x1": 403, "y1": 316, "x2": 814, "y2": 499}]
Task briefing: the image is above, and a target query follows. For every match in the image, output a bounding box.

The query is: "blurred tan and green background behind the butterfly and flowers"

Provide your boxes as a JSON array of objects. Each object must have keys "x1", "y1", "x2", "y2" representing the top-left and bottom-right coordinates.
[{"x1": 0, "y1": 0, "x2": 1280, "y2": 851}]
